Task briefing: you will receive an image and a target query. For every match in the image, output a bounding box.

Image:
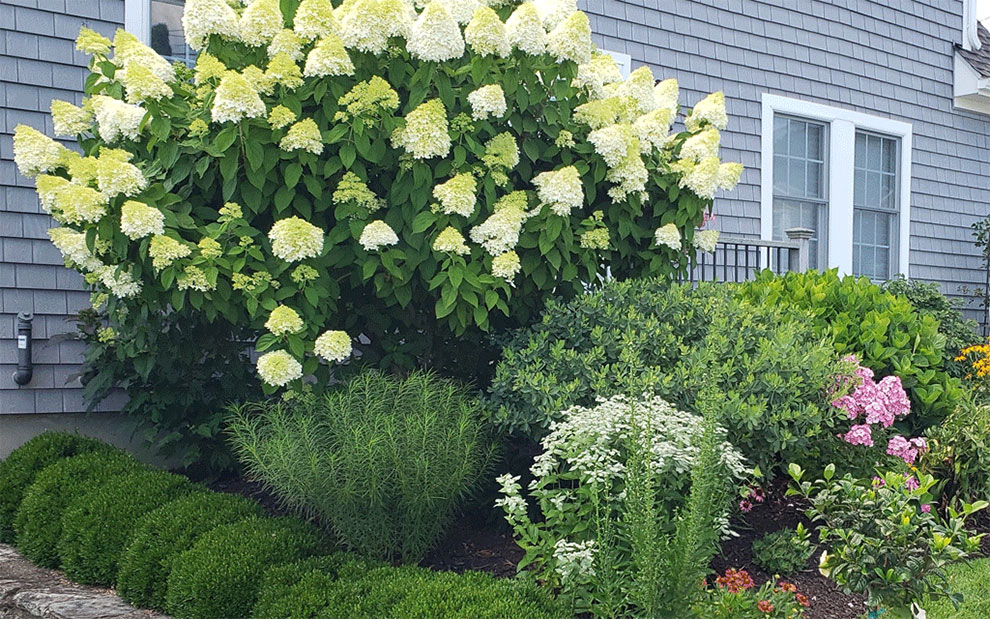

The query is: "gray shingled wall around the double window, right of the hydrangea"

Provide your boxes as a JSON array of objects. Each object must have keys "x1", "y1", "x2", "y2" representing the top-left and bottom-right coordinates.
[{"x1": 578, "y1": 0, "x2": 990, "y2": 318}]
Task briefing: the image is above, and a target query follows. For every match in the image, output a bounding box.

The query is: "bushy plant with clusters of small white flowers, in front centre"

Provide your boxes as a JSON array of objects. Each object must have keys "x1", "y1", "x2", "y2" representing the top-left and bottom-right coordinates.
[{"x1": 495, "y1": 395, "x2": 750, "y2": 597}]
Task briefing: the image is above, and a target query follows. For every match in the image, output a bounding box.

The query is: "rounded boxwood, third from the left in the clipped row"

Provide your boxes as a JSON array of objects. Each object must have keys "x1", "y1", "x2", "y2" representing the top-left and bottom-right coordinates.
[{"x1": 58, "y1": 471, "x2": 196, "y2": 586}]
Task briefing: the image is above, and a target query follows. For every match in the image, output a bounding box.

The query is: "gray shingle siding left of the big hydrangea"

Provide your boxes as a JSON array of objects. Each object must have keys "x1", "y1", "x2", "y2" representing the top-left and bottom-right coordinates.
[{"x1": 0, "y1": 0, "x2": 124, "y2": 414}]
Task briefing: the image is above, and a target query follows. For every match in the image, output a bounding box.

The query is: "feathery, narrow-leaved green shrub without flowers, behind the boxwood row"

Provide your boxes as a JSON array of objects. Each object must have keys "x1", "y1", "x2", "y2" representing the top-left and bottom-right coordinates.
[{"x1": 229, "y1": 371, "x2": 495, "y2": 561}]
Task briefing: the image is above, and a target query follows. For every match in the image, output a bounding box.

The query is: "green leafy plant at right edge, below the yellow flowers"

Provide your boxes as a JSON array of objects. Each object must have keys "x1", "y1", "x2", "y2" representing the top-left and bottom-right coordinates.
[{"x1": 918, "y1": 401, "x2": 990, "y2": 503}]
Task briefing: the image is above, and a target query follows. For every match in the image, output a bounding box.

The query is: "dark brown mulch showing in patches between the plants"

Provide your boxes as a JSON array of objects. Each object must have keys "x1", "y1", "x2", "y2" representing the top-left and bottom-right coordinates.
[{"x1": 211, "y1": 478, "x2": 990, "y2": 619}]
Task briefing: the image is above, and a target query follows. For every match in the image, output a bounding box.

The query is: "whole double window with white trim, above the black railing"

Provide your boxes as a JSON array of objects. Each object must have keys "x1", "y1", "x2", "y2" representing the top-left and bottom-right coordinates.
[{"x1": 761, "y1": 94, "x2": 912, "y2": 281}]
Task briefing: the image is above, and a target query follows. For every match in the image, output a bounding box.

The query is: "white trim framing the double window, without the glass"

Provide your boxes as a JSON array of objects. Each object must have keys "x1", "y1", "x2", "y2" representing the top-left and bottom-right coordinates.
[{"x1": 760, "y1": 93, "x2": 912, "y2": 277}]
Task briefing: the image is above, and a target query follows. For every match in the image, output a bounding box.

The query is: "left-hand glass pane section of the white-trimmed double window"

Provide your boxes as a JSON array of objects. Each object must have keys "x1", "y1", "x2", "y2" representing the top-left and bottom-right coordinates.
[{"x1": 773, "y1": 116, "x2": 828, "y2": 269}]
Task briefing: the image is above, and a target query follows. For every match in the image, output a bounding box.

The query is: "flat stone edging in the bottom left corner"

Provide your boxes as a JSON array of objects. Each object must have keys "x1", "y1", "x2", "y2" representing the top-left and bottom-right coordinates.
[{"x1": 0, "y1": 544, "x2": 168, "y2": 619}]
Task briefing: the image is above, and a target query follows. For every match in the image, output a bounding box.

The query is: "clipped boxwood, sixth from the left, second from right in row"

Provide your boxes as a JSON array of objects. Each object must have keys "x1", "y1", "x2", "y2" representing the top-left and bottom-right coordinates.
[{"x1": 251, "y1": 552, "x2": 381, "y2": 619}]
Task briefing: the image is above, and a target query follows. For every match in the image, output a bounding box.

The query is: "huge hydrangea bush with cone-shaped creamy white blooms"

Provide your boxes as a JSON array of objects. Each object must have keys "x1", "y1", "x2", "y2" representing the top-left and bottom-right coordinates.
[{"x1": 14, "y1": 0, "x2": 742, "y2": 387}]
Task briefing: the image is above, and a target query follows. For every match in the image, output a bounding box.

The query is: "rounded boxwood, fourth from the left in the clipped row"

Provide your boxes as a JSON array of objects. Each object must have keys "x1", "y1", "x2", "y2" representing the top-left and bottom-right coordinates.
[{"x1": 117, "y1": 492, "x2": 261, "y2": 611}]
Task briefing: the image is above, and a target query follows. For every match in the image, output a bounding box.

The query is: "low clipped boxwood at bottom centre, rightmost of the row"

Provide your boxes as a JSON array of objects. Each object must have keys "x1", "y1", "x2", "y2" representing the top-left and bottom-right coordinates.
[{"x1": 312, "y1": 567, "x2": 566, "y2": 619}]
